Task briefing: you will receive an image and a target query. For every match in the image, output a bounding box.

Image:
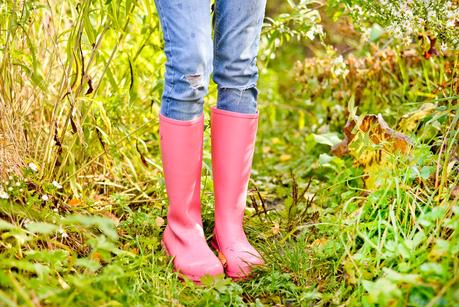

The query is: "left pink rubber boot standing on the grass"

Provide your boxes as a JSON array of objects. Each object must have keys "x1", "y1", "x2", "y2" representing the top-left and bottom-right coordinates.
[{"x1": 159, "y1": 115, "x2": 223, "y2": 283}]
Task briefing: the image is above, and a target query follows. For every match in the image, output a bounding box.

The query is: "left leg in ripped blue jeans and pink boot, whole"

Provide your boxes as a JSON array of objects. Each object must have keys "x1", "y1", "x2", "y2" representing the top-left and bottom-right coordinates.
[{"x1": 156, "y1": 0, "x2": 223, "y2": 282}]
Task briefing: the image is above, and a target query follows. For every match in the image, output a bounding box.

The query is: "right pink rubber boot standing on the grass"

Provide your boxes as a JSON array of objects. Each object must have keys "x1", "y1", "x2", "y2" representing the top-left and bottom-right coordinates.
[{"x1": 211, "y1": 108, "x2": 263, "y2": 279}]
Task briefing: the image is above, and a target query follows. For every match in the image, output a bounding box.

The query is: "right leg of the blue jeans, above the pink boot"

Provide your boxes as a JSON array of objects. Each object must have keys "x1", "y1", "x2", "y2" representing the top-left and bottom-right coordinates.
[{"x1": 213, "y1": 0, "x2": 266, "y2": 114}]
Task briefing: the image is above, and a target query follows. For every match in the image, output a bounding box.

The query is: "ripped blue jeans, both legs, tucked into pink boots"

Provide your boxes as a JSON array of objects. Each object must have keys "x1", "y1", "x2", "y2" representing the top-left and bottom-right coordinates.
[{"x1": 155, "y1": 0, "x2": 266, "y2": 120}]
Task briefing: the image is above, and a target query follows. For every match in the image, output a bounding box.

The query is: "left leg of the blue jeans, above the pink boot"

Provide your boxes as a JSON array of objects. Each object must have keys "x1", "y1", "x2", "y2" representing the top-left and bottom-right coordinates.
[{"x1": 155, "y1": 0, "x2": 213, "y2": 120}]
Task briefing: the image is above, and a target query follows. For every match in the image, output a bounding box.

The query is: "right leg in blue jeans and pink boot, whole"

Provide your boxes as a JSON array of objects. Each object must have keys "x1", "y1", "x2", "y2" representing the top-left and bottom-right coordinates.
[{"x1": 211, "y1": 0, "x2": 266, "y2": 278}]
